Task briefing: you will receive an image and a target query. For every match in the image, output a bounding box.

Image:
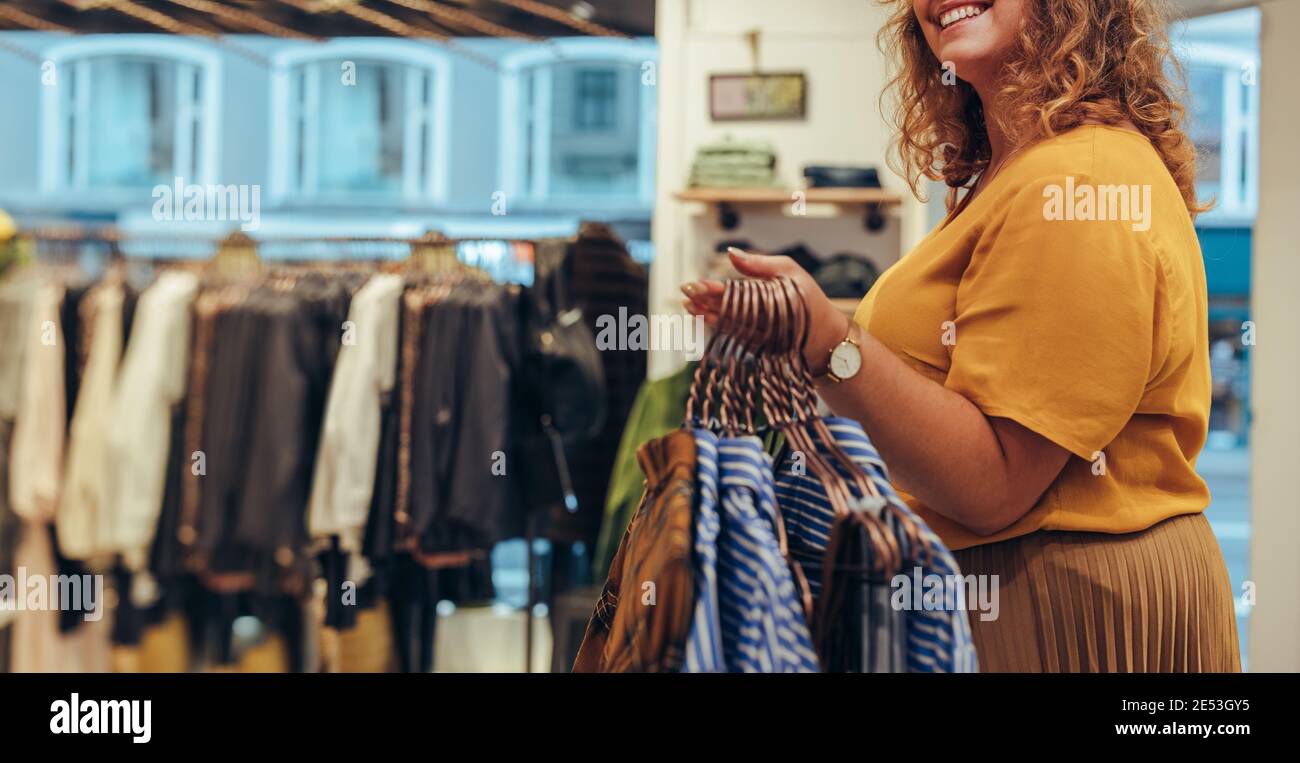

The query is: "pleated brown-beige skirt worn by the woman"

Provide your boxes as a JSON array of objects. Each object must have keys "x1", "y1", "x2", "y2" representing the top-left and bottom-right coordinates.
[{"x1": 954, "y1": 513, "x2": 1242, "y2": 672}]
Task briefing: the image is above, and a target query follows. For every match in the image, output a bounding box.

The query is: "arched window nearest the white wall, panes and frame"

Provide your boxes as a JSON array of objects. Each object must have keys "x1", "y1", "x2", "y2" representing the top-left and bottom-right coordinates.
[{"x1": 501, "y1": 39, "x2": 657, "y2": 208}]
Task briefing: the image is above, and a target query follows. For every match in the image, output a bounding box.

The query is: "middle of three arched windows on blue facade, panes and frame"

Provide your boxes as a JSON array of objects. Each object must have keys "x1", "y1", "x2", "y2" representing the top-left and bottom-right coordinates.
[{"x1": 270, "y1": 40, "x2": 451, "y2": 201}]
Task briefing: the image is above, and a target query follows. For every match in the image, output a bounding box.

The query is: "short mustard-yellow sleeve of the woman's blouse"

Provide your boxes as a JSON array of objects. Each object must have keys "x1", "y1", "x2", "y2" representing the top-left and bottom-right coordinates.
[{"x1": 945, "y1": 177, "x2": 1160, "y2": 459}]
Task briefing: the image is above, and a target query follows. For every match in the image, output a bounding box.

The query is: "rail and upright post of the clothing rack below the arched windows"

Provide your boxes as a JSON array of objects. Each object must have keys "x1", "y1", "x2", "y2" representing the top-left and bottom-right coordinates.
[{"x1": 20, "y1": 221, "x2": 564, "y2": 673}]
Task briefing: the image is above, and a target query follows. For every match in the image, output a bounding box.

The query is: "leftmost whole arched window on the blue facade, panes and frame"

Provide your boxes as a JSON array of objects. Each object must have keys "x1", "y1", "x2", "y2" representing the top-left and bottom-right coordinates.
[{"x1": 42, "y1": 35, "x2": 220, "y2": 192}]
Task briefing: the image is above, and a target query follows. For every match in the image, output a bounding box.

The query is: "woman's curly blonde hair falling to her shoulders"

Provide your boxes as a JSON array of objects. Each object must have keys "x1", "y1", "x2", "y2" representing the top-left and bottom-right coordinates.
[{"x1": 879, "y1": 0, "x2": 1209, "y2": 216}]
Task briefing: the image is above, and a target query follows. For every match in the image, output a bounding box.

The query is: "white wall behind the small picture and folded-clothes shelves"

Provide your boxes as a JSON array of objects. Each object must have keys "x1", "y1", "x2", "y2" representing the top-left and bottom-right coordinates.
[{"x1": 650, "y1": 0, "x2": 924, "y2": 377}]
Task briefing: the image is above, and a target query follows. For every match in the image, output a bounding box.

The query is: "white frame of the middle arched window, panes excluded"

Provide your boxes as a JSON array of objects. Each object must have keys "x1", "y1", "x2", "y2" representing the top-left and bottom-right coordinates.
[{"x1": 267, "y1": 39, "x2": 452, "y2": 205}]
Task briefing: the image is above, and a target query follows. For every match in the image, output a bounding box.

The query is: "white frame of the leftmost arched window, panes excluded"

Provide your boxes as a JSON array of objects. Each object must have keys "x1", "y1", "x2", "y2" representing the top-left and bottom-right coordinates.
[{"x1": 39, "y1": 34, "x2": 221, "y2": 201}]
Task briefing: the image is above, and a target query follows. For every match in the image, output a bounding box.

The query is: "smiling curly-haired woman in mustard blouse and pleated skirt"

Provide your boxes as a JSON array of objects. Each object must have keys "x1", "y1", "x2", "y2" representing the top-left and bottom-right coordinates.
[{"x1": 683, "y1": 0, "x2": 1240, "y2": 671}]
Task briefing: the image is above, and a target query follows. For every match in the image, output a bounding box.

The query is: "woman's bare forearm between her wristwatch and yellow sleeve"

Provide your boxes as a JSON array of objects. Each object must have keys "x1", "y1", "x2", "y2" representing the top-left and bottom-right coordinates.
[{"x1": 818, "y1": 331, "x2": 1067, "y2": 534}]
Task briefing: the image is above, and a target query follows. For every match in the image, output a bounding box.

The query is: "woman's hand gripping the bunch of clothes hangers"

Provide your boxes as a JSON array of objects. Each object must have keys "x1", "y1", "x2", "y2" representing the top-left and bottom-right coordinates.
[{"x1": 681, "y1": 247, "x2": 849, "y2": 374}]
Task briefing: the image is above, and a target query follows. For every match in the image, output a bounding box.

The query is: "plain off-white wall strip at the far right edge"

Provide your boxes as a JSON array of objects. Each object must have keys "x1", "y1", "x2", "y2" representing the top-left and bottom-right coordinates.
[{"x1": 1249, "y1": 0, "x2": 1300, "y2": 672}]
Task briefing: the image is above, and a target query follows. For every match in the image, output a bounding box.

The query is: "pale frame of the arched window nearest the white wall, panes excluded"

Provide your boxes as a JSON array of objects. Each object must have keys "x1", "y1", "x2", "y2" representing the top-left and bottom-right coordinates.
[{"x1": 497, "y1": 38, "x2": 659, "y2": 211}]
